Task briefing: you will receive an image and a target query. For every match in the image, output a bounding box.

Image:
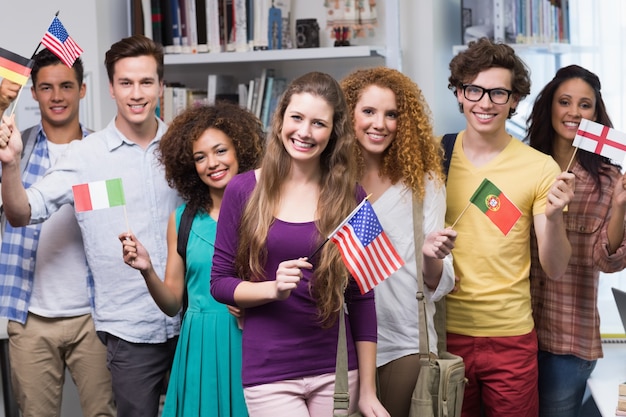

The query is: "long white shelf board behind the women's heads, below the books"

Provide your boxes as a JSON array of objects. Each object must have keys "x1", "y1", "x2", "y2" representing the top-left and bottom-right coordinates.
[{"x1": 164, "y1": 46, "x2": 384, "y2": 65}]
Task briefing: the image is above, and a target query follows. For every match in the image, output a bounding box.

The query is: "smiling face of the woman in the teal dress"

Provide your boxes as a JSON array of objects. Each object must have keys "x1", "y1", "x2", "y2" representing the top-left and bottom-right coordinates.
[{"x1": 193, "y1": 128, "x2": 239, "y2": 190}]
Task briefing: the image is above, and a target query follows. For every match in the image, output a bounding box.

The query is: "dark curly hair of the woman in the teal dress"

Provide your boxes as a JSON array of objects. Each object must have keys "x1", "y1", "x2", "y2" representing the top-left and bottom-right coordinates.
[{"x1": 157, "y1": 102, "x2": 264, "y2": 211}]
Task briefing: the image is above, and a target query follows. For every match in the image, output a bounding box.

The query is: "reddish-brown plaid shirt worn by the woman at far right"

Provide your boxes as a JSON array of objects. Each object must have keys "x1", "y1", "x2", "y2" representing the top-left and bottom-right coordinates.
[{"x1": 531, "y1": 164, "x2": 626, "y2": 360}]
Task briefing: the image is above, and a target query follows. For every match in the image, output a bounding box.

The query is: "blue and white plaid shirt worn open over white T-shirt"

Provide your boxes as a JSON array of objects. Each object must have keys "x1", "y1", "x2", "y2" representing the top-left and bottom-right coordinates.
[{"x1": 0, "y1": 124, "x2": 93, "y2": 324}]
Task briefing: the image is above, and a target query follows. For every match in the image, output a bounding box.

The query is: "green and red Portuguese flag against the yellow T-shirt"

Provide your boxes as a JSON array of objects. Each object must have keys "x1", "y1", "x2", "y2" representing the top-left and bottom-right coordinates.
[{"x1": 470, "y1": 178, "x2": 522, "y2": 236}]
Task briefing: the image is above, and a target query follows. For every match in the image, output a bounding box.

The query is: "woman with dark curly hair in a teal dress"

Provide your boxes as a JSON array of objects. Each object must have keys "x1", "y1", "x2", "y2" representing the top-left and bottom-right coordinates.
[{"x1": 120, "y1": 103, "x2": 263, "y2": 417}]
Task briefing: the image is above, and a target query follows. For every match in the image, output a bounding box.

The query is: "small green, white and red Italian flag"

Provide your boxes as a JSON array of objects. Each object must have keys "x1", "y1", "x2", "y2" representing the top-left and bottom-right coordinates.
[{"x1": 72, "y1": 178, "x2": 126, "y2": 213}]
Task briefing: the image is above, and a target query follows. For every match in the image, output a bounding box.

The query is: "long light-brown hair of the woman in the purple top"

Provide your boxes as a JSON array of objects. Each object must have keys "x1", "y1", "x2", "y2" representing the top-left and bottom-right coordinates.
[{"x1": 235, "y1": 72, "x2": 357, "y2": 327}]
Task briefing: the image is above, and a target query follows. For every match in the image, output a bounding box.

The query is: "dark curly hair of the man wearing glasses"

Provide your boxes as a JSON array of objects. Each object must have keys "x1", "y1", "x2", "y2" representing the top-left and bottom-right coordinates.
[{"x1": 448, "y1": 38, "x2": 530, "y2": 117}]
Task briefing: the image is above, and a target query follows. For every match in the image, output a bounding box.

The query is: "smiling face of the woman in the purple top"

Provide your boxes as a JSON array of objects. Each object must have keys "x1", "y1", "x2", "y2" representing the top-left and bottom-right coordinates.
[{"x1": 281, "y1": 93, "x2": 334, "y2": 167}]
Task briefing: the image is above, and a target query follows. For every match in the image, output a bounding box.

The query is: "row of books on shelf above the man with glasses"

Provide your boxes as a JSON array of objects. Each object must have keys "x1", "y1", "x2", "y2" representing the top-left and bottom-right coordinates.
[{"x1": 461, "y1": 0, "x2": 569, "y2": 44}]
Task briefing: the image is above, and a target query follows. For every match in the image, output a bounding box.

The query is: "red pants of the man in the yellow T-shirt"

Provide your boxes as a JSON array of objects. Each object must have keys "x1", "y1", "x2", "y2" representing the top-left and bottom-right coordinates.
[{"x1": 448, "y1": 330, "x2": 539, "y2": 417}]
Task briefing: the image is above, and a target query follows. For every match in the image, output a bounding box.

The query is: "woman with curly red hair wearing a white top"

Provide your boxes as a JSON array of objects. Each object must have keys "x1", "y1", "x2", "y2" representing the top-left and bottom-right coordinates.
[{"x1": 341, "y1": 67, "x2": 456, "y2": 417}]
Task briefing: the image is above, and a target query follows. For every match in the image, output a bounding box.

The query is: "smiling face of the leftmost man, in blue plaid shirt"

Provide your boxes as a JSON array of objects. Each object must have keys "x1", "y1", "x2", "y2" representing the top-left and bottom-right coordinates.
[{"x1": 31, "y1": 63, "x2": 86, "y2": 127}]
